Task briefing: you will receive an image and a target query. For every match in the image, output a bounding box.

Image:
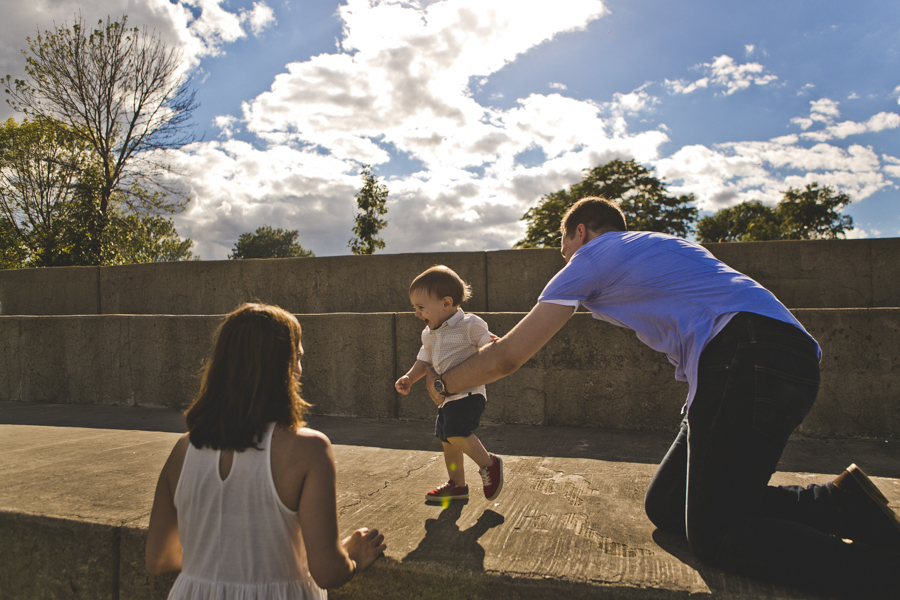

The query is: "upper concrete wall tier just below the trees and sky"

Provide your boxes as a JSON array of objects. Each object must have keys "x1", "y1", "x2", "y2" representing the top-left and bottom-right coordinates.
[{"x1": 0, "y1": 238, "x2": 900, "y2": 315}]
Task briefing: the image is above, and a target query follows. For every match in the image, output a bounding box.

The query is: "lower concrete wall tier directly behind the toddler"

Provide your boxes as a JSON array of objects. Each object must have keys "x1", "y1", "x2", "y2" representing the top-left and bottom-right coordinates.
[{"x1": 0, "y1": 309, "x2": 900, "y2": 438}]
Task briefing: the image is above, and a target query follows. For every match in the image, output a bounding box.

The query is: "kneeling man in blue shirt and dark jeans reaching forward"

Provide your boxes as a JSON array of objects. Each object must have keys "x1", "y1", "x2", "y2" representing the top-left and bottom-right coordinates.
[{"x1": 428, "y1": 198, "x2": 900, "y2": 598}]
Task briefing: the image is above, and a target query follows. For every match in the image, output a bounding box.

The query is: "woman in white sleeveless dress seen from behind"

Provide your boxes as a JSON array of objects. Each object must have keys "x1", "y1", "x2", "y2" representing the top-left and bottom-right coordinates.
[{"x1": 146, "y1": 304, "x2": 386, "y2": 600}]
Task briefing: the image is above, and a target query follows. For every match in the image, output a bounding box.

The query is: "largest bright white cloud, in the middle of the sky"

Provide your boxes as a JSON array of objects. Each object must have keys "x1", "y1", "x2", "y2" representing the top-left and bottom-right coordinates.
[{"x1": 171, "y1": 0, "x2": 652, "y2": 257}]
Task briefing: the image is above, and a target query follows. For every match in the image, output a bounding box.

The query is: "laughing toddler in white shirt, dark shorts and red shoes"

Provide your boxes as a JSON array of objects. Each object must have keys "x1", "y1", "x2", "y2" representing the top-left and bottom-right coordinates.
[{"x1": 394, "y1": 265, "x2": 503, "y2": 503}]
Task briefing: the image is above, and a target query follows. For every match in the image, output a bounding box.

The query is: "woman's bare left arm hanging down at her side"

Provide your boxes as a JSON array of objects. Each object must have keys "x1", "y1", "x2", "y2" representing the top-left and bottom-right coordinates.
[{"x1": 144, "y1": 434, "x2": 190, "y2": 575}]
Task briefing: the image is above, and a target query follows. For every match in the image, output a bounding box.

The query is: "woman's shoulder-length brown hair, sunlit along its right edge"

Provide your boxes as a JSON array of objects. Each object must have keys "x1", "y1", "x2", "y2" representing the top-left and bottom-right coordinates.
[{"x1": 185, "y1": 304, "x2": 310, "y2": 451}]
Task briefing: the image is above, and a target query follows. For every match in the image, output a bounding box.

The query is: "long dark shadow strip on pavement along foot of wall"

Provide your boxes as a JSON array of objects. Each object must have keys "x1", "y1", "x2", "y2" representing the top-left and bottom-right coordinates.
[{"x1": 7, "y1": 402, "x2": 900, "y2": 478}]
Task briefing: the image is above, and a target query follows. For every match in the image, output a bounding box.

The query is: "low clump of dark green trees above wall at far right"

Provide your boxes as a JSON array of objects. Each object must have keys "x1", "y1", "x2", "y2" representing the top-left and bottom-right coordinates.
[{"x1": 697, "y1": 183, "x2": 853, "y2": 243}]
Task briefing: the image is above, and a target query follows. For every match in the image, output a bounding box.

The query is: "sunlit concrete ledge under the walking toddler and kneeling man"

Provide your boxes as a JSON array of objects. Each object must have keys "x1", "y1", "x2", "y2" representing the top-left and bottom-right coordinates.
[{"x1": 0, "y1": 403, "x2": 900, "y2": 600}]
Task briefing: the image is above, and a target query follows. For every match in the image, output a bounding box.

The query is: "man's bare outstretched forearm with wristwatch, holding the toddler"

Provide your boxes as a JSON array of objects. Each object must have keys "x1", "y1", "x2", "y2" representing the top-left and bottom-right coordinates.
[{"x1": 426, "y1": 302, "x2": 575, "y2": 399}]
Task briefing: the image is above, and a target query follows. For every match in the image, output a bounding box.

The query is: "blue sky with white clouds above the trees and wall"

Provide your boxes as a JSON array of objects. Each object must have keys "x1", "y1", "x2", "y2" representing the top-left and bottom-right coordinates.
[{"x1": 0, "y1": 0, "x2": 900, "y2": 260}]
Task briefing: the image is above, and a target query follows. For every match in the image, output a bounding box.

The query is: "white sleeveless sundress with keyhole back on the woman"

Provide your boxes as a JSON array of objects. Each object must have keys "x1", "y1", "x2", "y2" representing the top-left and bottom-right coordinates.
[{"x1": 169, "y1": 423, "x2": 327, "y2": 600}]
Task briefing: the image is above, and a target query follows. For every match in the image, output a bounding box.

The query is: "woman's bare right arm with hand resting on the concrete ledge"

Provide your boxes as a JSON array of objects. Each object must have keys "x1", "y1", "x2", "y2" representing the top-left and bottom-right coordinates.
[{"x1": 298, "y1": 430, "x2": 386, "y2": 589}]
